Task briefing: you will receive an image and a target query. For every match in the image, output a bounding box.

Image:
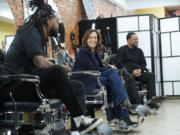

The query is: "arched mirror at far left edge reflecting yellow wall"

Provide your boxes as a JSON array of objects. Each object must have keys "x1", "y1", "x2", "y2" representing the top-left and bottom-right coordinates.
[{"x1": 0, "y1": 0, "x2": 14, "y2": 53}]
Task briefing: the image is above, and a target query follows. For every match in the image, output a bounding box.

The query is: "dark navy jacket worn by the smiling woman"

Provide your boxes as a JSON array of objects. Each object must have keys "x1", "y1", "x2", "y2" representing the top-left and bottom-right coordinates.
[{"x1": 72, "y1": 48, "x2": 110, "y2": 91}]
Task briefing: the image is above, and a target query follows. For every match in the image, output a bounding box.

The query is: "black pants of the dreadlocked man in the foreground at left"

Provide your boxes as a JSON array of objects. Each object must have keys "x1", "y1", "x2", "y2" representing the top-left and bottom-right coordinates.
[{"x1": 39, "y1": 65, "x2": 84, "y2": 117}]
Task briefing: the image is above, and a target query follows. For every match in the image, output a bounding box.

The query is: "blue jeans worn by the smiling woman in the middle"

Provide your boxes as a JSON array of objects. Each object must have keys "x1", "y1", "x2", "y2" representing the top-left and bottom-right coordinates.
[{"x1": 100, "y1": 68, "x2": 129, "y2": 120}]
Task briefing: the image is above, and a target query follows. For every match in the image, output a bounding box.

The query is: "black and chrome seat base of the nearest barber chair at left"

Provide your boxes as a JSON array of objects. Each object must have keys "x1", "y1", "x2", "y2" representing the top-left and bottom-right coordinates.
[{"x1": 0, "y1": 99, "x2": 63, "y2": 127}]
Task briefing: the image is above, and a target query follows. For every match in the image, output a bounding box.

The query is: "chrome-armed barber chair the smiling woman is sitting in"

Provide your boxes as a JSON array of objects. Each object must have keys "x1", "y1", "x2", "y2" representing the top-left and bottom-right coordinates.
[{"x1": 69, "y1": 70, "x2": 114, "y2": 135}]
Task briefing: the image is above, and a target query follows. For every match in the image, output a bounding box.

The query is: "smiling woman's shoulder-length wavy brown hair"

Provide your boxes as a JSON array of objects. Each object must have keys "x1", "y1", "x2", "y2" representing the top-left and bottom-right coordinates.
[{"x1": 82, "y1": 29, "x2": 102, "y2": 52}]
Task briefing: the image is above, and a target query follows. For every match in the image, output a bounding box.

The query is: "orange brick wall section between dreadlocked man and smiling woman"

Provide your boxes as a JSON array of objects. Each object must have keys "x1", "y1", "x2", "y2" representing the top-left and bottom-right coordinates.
[{"x1": 54, "y1": 0, "x2": 85, "y2": 51}]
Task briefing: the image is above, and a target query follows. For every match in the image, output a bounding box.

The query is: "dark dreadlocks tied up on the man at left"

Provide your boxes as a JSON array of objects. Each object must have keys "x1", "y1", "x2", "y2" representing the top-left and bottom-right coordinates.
[{"x1": 17, "y1": 0, "x2": 55, "y2": 34}]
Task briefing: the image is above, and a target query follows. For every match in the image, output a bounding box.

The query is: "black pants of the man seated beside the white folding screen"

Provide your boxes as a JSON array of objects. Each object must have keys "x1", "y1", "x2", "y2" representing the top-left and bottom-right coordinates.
[{"x1": 135, "y1": 72, "x2": 156, "y2": 99}]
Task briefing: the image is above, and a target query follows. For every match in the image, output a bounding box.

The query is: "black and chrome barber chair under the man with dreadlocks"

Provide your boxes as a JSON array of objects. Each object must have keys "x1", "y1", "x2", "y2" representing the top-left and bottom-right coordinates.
[{"x1": 0, "y1": 74, "x2": 67, "y2": 135}]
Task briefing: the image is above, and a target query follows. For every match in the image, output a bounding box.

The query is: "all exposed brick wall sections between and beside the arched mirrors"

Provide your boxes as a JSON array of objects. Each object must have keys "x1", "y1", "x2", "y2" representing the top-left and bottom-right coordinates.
[{"x1": 7, "y1": 0, "x2": 126, "y2": 51}]
